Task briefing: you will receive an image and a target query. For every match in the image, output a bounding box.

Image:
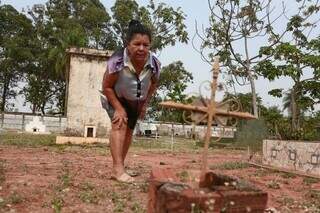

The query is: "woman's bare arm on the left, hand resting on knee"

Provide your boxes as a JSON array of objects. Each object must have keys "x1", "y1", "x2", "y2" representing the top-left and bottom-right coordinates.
[{"x1": 103, "y1": 72, "x2": 127, "y2": 128}]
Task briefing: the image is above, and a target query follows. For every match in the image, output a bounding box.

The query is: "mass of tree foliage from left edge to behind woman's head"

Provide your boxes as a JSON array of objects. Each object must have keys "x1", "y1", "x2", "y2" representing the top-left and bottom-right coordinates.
[{"x1": 0, "y1": 0, "x2": 188, "y2": 114}]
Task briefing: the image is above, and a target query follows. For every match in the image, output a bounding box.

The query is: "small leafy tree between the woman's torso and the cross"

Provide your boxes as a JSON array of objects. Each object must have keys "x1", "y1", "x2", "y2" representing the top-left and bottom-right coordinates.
[{"x1": 148, "y1": 61, "x2": 193, "y2": 123}]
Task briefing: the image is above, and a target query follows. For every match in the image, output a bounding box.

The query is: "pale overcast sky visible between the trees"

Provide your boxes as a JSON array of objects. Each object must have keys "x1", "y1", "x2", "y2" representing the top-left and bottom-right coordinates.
[{"x1": 2, "y1": 0, "x2": 319, "y2": 108}]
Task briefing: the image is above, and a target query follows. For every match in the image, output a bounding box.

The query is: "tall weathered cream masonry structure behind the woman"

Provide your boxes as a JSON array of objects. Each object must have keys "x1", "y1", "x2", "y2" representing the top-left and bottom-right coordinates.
[{"x1": 67, "y1": 49, "x2": 111, "y2": 137}]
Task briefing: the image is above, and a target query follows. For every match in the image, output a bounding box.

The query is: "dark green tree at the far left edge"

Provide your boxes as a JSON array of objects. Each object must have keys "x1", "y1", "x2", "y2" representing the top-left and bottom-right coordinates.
[{"x1": 0, "y1": 5, "x2": 33, "y2": 111}]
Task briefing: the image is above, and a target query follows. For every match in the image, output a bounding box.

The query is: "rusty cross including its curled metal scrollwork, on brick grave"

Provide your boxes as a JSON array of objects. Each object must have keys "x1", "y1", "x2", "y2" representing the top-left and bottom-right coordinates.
[{"x1": 160, "y1": 57, "x2": 256, "y2": 185}]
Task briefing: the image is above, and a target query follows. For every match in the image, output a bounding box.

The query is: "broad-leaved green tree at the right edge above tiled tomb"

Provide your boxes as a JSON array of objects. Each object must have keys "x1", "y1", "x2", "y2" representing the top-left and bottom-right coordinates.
[{"x1": 255, "y1": 5, "x2": 320, "y2": 132}]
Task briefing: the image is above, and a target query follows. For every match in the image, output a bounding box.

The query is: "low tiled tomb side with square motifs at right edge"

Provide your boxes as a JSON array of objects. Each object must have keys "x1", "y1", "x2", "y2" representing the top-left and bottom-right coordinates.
[{"x1": 263, "y1": 140, "x2": 320, "y2": 176}]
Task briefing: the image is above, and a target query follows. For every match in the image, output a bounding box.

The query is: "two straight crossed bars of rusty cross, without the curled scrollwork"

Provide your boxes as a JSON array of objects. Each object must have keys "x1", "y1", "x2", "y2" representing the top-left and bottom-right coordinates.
[{"x1": 160, "y1": 57, "x2": 256, "y2": 185}]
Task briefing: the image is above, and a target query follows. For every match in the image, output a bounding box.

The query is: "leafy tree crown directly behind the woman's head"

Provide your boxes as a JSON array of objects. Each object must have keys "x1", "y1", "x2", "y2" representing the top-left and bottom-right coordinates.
[{"x1": 111, "y1": 0, "x2": 188, "y2": 51}]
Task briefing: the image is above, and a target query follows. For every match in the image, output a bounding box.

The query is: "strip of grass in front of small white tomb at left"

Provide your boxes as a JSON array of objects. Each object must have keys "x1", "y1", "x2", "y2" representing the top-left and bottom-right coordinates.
[{"x1": 0, "y1": 133, "x2": 56, "y2": 147}]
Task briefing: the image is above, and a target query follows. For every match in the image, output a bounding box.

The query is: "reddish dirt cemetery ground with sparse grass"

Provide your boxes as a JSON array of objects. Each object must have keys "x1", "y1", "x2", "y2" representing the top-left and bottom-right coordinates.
[{"x1": 0, "y1": 133, "x2": 320, "y2": 212}]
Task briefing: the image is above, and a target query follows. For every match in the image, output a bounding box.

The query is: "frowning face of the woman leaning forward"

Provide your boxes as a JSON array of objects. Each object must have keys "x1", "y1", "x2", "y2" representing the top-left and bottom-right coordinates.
[{"x1": 127, "y1": 34, "x2": 150, "y2": 65}]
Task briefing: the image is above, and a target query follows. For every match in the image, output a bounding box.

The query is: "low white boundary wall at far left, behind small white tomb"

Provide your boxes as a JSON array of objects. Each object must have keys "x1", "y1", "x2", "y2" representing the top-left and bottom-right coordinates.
[{"x1": 0, "y1": 113, "x2": 67, "y2": 133}]
